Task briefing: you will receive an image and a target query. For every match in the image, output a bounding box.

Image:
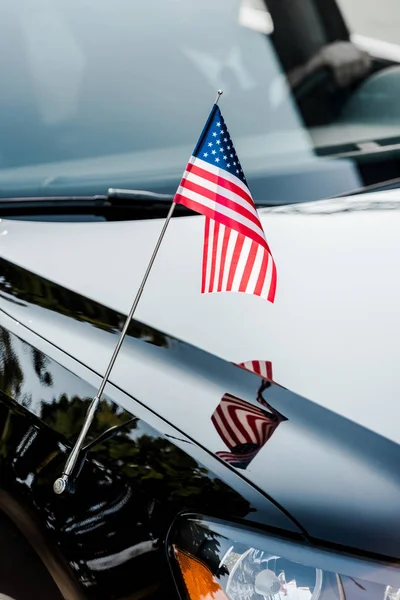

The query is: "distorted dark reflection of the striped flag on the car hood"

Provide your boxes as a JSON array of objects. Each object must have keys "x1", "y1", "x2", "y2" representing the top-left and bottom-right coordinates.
[{"x1": 211, "y1": 394, "x2": 287, "y2": 469}]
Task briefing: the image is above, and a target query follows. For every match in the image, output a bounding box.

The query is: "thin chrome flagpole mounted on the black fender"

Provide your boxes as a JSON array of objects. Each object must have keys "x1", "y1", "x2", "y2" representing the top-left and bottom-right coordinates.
[{"x1": 53, "y1": 90, "x2": 223, "y2": 494}]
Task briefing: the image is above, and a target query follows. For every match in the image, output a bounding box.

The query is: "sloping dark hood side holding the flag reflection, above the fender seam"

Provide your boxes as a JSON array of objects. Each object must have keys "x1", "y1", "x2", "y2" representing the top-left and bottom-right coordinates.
[{"x1": 0, "y1": 251, "x2": 400, "y2": 557}]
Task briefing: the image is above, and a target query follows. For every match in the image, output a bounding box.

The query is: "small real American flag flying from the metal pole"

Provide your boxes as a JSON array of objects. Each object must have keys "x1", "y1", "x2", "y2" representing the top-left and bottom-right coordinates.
[{"x1": 174, "y1": 104, "x2": 277, "y2": 302}]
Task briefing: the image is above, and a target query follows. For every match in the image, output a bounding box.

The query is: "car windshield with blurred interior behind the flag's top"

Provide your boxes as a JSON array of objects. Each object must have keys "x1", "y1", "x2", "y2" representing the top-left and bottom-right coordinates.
[{"x1": 0, "y1": 0, "x2": 400, "y2": 204}]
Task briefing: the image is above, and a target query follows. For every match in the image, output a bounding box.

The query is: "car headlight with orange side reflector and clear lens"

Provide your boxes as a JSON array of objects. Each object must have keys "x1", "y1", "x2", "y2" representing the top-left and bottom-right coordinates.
[{"x1": 169, "y1": 516, "x2": 400, "y2": 600}]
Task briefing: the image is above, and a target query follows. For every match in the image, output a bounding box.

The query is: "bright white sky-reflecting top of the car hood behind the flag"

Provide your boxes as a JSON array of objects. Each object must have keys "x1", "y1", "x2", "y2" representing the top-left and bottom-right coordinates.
[{"x1": 0, "y1": 190, "x2": 400, "y2": 442}]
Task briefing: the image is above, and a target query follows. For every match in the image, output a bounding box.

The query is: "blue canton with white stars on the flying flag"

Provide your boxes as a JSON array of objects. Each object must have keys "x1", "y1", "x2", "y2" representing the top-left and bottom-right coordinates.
[{"x1": 193, "y1": 105, "x2": 247, "y2": 185}]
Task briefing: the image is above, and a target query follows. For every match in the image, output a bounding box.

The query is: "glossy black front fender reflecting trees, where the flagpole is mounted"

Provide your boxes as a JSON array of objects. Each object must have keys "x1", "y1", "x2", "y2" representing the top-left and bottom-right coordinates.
[{"x1": 0, "y1": 314, "x2": 301, "y2": 599}]
